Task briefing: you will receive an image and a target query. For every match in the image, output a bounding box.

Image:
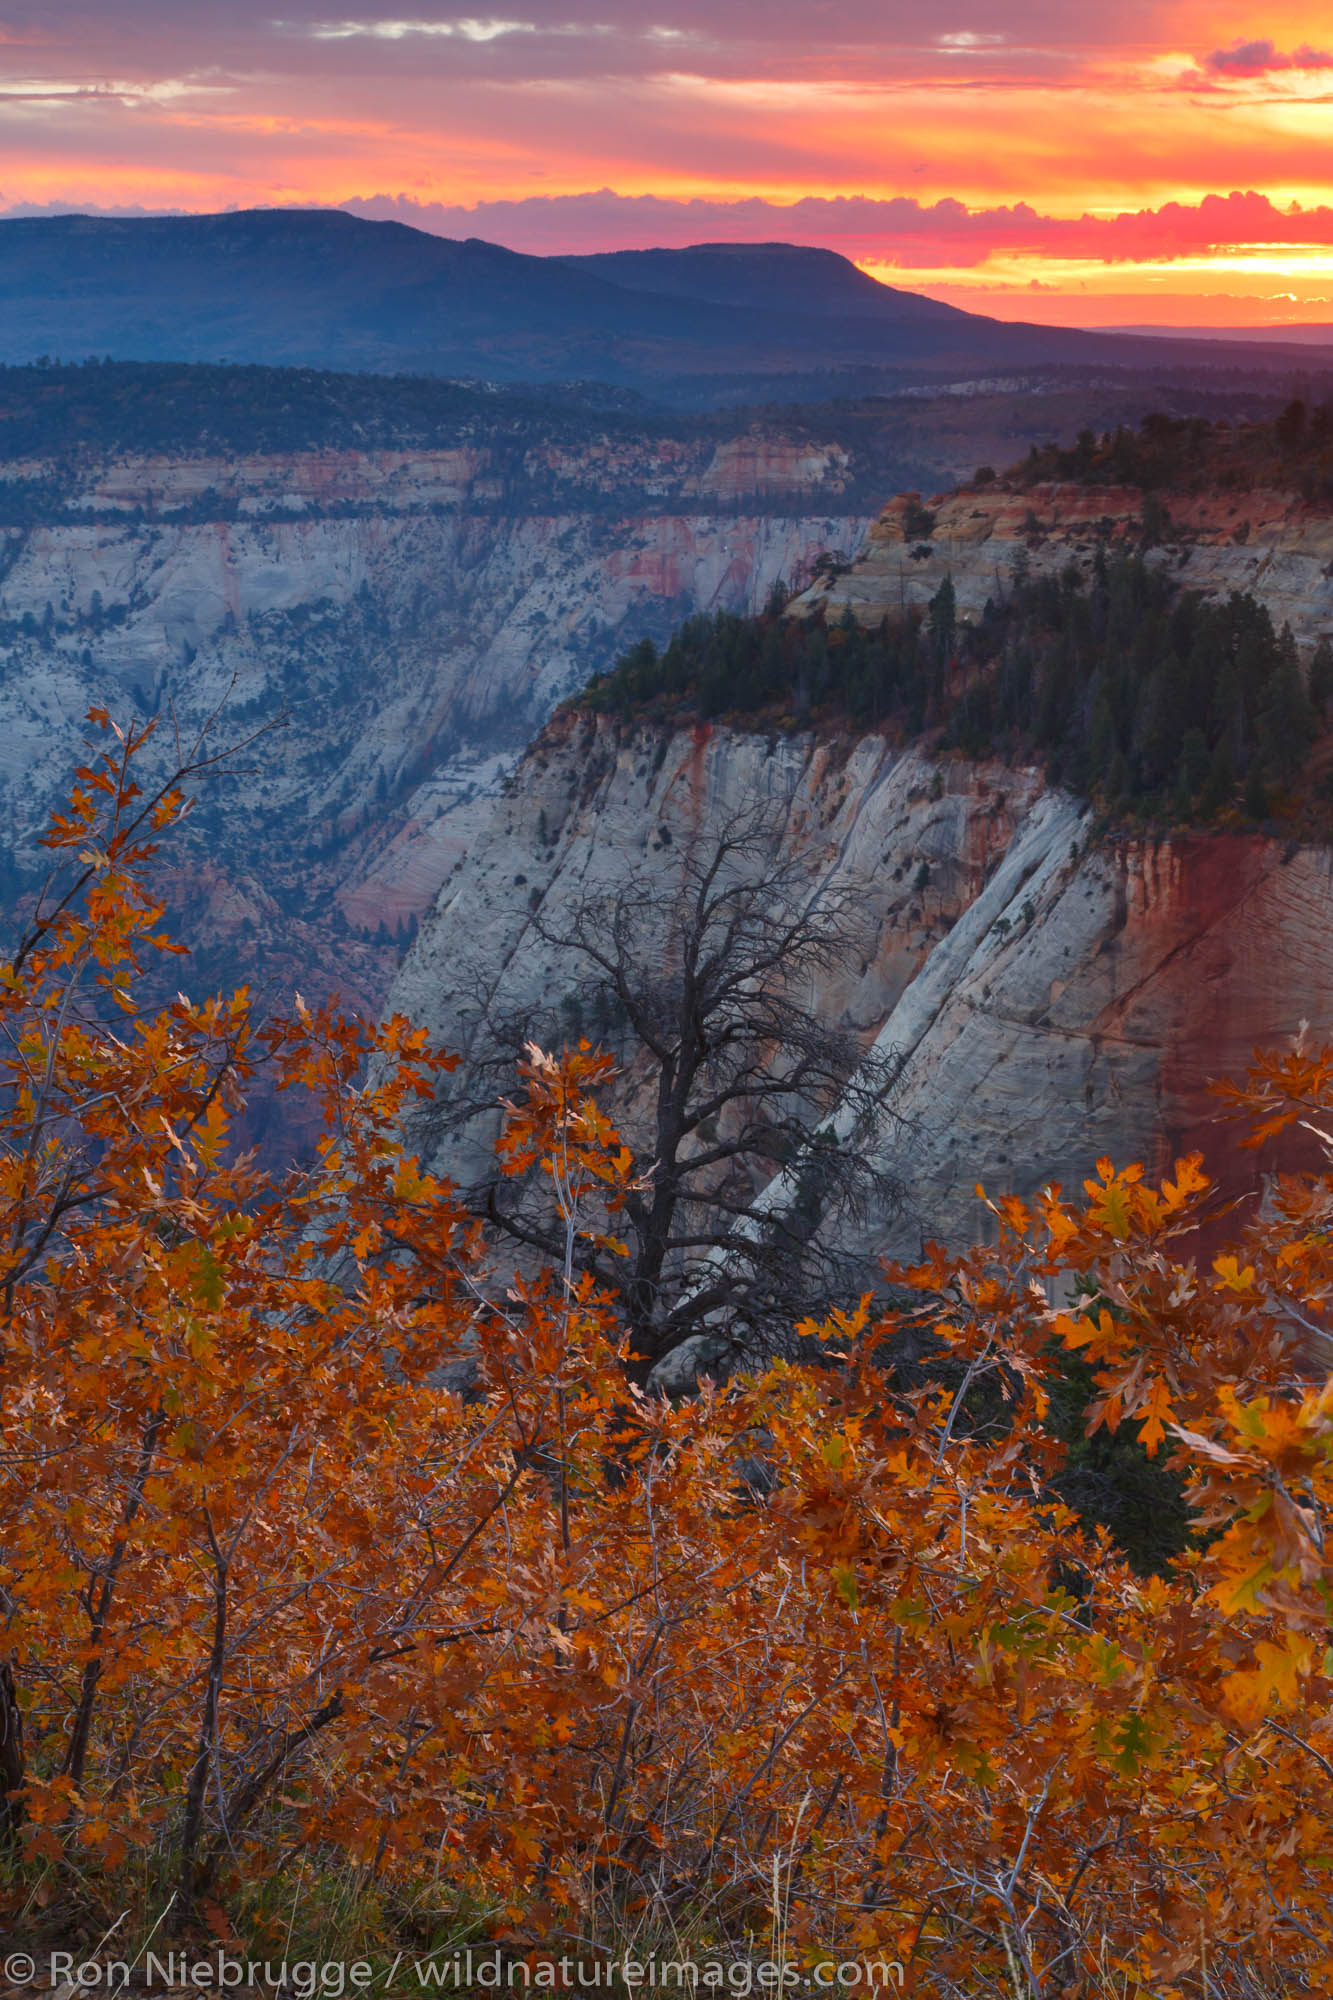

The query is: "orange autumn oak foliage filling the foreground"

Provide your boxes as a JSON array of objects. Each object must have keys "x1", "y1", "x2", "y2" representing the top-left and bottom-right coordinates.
[{"x1": 0, "y1": 716, "x2": 1333, "y2": 2000}]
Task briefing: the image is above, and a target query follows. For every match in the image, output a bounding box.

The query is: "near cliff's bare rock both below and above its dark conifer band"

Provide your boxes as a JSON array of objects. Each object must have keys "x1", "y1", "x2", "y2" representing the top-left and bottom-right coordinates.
[{"x1": 390, "y1": 466, "x2": 1333, "y2": 1260}]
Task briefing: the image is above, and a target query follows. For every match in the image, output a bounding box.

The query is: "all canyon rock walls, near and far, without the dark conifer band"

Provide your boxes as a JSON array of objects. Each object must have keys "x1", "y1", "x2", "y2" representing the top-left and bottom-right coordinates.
[{"x1": 0, "y1": 368, "x2": 1333, "y2": 1252}]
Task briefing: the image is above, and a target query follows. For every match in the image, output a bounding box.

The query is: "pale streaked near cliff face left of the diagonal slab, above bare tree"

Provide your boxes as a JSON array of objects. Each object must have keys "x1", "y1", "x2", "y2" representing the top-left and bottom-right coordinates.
[{"x1": 390, "y1": 714, "x2": 1039, "y2": 1144}]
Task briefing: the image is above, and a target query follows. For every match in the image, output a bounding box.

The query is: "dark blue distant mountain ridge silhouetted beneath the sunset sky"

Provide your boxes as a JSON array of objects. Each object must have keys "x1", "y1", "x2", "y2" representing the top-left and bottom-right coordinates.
[{"x1": 0, "y1": 210, "x2": 1320, "y2": 400}]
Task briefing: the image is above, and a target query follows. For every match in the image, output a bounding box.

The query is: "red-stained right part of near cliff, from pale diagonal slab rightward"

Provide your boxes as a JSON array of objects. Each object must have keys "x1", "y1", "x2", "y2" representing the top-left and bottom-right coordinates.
[{"x1": 840, "y1": 812, "x2": 1333, "y2": 1234}]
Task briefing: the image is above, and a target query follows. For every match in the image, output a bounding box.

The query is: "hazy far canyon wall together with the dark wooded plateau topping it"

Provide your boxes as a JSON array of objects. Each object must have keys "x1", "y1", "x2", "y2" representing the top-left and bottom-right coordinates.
[{"x1": 0, "y1": 362, "x2": 1271, "y2": 1014}]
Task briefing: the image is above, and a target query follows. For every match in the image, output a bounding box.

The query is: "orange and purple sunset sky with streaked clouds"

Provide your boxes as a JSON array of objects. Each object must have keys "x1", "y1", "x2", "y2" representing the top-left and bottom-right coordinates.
[{"x1": 0, "y1": 0, "x2": 1333, "y2": 326}]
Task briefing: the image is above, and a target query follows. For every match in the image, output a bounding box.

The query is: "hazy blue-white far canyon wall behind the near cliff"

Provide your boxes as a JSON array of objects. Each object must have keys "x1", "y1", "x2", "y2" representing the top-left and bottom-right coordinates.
[{"x1": 0, "y1": 440, "x2": 869, "y2": 1012}]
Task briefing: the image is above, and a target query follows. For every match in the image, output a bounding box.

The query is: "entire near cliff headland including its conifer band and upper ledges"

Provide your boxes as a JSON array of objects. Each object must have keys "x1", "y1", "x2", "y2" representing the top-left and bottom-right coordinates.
[{"x1": 396, "y1": 408, "x2": 1333, "y2": 1288}]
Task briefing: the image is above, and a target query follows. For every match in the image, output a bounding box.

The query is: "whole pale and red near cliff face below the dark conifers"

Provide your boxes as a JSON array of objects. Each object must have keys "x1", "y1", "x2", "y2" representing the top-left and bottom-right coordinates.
[{"x1": 390, "y1": 716, "x2": 1333, "y2": 1254}]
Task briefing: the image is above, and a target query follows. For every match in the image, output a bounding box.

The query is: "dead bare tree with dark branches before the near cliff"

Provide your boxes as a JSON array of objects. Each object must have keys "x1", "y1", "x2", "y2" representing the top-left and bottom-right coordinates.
[{"x1": 436, "y1": 808, "x2": 901, "y2": 1380}]
